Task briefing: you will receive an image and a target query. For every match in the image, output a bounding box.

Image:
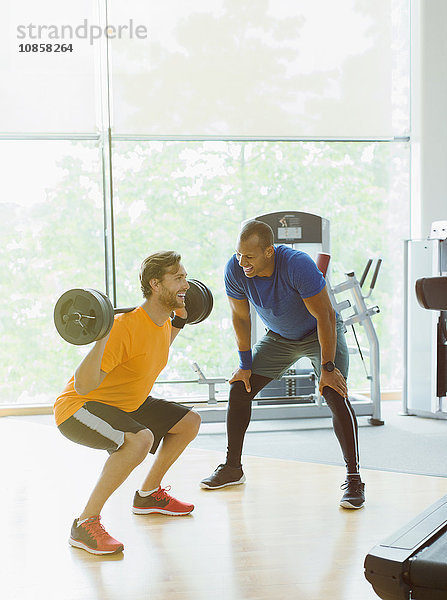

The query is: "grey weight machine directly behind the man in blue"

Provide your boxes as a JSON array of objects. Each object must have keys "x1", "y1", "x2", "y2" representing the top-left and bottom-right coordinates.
[{"x1": 200, "y1": 211, "x2": 383, "y2": 425}]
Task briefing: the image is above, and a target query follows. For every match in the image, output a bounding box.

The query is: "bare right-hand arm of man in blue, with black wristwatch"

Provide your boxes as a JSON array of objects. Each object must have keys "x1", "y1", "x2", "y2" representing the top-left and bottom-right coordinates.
[{"x1": 303, "y1": 287, "x2": 348, "y2": 398}]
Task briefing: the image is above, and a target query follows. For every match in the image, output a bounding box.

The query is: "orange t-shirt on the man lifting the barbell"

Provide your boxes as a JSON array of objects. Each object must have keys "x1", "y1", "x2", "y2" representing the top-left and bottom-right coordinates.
[{"x1": 54, "y1": 306, "x2": 171, "y2": 425}]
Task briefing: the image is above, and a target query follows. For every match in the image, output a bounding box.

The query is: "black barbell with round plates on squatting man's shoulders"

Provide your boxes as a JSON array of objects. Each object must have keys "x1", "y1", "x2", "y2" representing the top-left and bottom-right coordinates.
[{"x1": 54, "y1": 279, "x2": 213, "y2": 346}]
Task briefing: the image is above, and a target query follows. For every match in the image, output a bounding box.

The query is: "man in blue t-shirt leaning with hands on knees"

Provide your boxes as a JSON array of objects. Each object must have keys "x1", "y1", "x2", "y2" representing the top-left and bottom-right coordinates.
[{"x1": 201, "y1": 220, "x2": 365, "y2": 508}]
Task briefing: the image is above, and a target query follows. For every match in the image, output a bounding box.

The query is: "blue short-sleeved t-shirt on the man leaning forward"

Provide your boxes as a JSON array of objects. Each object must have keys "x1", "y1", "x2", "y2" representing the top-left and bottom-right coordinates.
[{"x1": 225, "y1": 244, "x2": 326, "y2": 340}]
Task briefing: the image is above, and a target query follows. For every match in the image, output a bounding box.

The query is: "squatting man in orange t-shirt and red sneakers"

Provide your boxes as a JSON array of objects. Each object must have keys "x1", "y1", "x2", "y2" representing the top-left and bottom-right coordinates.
[{"x1": 54, "y1": 251, "x2": 200, "y2": 554}]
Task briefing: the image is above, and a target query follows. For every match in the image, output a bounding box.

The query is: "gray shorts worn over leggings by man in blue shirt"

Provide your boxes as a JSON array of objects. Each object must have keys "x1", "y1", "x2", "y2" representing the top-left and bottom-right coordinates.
[{"x1": 251, "y1": 316, "x2": 349, "y2": 379}]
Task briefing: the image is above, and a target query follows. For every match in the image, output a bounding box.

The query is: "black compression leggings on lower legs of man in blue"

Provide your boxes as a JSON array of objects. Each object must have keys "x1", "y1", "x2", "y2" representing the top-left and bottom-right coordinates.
[{"x1": 227, "y1": 374, "x2": 359, "y2": 475}]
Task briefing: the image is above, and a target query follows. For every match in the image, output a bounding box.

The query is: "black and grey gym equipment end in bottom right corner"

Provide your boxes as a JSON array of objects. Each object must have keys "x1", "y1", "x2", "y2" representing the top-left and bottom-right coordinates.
[{"x1": 364, "y1": 496, "x2": 447, "y2": 600}]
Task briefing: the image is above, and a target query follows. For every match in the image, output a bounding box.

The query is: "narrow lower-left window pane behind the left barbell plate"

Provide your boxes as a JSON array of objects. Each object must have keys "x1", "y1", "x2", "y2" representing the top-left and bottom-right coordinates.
[{"x1": 0, "y1": 141, "x2": 104, "y2": 404}]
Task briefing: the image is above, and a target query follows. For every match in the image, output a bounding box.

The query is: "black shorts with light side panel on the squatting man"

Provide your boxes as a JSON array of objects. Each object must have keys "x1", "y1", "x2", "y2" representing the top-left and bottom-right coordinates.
[{"x1": 58, "y1": 396, "x2": 191, "y2": 454}]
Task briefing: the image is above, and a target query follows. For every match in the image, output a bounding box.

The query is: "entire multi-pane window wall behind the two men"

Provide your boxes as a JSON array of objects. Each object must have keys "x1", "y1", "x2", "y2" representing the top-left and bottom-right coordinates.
[{"x1": 0, "y1": 0, "x2": 410, "y2": 404}]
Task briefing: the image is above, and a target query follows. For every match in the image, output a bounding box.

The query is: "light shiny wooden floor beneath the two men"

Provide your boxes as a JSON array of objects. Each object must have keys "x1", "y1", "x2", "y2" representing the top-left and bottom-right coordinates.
[{"x1": 0, "y1": 418, "x2": 447, "y2": 600}]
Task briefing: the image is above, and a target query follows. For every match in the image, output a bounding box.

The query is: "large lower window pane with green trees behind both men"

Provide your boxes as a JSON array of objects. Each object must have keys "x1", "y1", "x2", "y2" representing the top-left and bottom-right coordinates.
[{"x1": 113, "y1": 142, "x2": 409, "y2": 393}]
